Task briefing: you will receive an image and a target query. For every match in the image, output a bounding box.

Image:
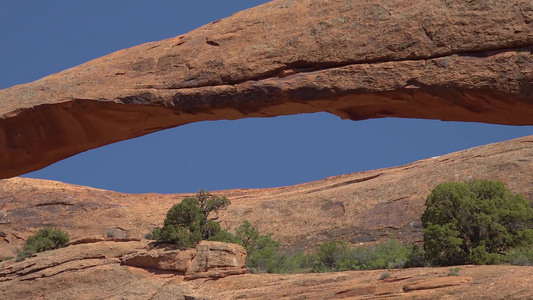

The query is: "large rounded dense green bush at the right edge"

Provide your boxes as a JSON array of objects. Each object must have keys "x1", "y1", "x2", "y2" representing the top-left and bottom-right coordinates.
[{"x1": 422, "y1": 180, "x2": 533, "y2": 265}]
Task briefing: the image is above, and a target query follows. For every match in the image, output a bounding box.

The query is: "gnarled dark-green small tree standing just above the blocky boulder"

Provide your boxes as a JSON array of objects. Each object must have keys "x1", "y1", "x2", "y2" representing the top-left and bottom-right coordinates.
[{"x1": 152, "y1": 190, "x2": 231, "y2": 249}]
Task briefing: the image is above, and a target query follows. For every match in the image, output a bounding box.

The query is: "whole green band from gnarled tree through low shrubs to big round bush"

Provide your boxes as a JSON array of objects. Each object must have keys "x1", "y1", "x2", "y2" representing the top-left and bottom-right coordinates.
[{"x1": 152, "y1": 180, "x2": 533, "y2": 279}]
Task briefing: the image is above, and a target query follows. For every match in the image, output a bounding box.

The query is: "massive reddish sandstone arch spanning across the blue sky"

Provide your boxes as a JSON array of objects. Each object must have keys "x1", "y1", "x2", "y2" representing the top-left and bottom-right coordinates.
[{"x1": 0, "y1": 0, "x2": 533, "y2": 178}]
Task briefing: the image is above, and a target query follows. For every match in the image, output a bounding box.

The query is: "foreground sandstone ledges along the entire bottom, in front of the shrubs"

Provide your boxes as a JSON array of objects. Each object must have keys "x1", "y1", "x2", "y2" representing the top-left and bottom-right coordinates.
[{"x1": 4, "y1": 242, "x2": 533, "y2": 300}]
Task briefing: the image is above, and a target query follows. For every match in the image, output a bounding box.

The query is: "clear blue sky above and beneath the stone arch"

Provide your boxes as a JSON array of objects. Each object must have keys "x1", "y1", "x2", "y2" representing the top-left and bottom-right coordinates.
[{"x1": 0, "y1": 0, "x2": 533, "y2": 193}]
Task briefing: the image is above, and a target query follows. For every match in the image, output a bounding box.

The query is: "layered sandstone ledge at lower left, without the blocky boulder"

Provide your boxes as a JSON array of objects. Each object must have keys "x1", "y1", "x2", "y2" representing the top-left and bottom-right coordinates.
[{"x1": 0, "y1": 241, "x2": 193, "y2": 300}]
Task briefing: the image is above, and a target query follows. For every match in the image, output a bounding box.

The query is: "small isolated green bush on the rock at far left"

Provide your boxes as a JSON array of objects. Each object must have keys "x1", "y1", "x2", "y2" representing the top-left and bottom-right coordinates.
[{"x1": 17, "y1": 227, "x2": 69, "y2": 261}]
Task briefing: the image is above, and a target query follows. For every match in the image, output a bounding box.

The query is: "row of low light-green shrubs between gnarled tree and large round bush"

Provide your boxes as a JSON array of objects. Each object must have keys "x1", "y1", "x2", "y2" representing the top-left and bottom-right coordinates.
[{"x1": 231, "y1": 237, "x2": 427, "y2": 274}]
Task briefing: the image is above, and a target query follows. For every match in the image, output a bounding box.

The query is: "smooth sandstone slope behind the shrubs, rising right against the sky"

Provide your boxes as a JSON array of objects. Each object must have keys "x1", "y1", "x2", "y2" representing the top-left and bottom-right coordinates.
[{"x1": 0, "y1": 136, "x2": 533, "y2": 257}]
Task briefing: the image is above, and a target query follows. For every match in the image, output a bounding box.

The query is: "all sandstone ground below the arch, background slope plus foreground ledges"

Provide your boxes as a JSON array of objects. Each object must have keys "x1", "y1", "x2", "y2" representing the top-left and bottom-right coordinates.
[{"x1": 0, "y1": 136, "x2": 533, "y2": 299}]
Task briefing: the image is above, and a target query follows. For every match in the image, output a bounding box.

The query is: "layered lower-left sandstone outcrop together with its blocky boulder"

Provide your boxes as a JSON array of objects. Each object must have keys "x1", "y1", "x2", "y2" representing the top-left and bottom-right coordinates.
[{"x1": 0, "y1": 240, "x2": 246, "y2": 299}]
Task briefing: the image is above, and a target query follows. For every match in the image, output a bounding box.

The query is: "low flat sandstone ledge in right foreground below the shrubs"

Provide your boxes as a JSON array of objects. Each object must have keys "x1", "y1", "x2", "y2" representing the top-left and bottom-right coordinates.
[{"x1": 192, "y1": 266, "x2": 533, "y2": 299}]
